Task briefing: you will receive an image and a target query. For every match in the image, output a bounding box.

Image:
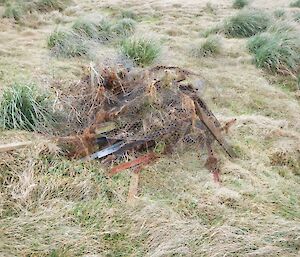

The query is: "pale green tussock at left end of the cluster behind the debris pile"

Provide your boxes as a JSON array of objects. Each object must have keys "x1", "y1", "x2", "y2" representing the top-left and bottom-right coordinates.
[{"x1": 47, "y1": 30, "x2": 90, "y2": 57}]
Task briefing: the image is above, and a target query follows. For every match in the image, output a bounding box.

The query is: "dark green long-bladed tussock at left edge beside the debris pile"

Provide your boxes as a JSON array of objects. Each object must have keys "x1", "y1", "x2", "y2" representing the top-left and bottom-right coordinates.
[{"x1": 0, "y1": 83, "x2": 54, "y2": 131}]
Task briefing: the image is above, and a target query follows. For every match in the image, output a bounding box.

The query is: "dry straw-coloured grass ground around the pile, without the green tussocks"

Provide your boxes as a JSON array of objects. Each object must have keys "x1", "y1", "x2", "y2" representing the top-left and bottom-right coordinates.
[{"x1": 0, "y1": 0, "x2": 300, "y2": 256}]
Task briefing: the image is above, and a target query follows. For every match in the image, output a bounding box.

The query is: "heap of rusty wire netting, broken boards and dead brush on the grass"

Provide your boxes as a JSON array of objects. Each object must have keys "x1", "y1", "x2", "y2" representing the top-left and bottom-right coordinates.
[{"x1": 61, "y1": 66, "x2": 235, "y2": 180}]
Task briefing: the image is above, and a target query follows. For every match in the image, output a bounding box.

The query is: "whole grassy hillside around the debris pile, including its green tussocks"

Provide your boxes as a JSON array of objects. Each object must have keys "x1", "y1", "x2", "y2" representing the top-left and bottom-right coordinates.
[{"x1": 0, "y1": 0, "x2": 300, "y2": 257}]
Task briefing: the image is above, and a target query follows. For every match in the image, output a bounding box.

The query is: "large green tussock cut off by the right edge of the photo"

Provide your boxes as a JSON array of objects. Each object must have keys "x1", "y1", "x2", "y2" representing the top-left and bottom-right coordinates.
[{"x1": 248, "y1": 30, "x2": 300, "y2": 73}]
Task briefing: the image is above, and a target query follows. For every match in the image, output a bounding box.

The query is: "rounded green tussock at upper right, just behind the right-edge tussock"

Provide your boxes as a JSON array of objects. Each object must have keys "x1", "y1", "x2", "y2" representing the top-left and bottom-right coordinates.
[{"x1": 223, "y1": 10, "x2": 271, "y2": 38}]
